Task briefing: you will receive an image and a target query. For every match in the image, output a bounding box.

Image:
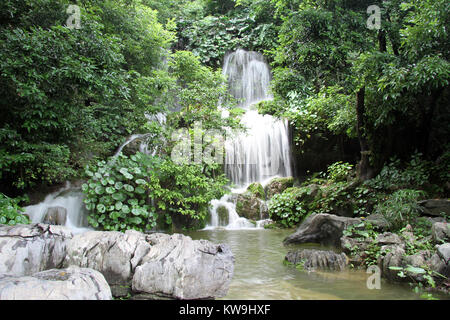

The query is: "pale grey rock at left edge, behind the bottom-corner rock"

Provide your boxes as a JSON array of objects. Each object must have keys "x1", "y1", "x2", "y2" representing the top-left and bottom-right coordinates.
[{"x1": 0, "y1": 223, "x2": 73, "y2": 276}]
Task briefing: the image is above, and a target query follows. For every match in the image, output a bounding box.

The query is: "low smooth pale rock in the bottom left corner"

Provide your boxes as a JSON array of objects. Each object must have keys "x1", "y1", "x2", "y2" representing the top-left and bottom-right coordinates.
[{"x1": 0, "y1": 266, "x2": 112, "y2": 300}]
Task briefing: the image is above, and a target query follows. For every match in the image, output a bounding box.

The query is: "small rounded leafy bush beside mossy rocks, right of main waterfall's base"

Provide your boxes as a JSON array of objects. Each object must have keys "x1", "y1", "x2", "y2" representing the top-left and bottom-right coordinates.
[{"x1": 268, "y1": 191, "x2": 307, "y2": 228}]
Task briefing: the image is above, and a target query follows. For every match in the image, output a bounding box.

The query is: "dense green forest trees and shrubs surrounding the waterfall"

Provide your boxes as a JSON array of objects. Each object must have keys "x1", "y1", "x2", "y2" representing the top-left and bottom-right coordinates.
[{"x1": 0, "y1": 0, "x2": 450, "y2": 230}]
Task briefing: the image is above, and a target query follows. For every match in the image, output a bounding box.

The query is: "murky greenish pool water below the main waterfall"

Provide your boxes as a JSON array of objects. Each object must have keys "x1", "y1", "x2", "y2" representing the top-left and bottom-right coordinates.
[{"x1": 187, "y1": 230, "x2": 448, "y2": 300}]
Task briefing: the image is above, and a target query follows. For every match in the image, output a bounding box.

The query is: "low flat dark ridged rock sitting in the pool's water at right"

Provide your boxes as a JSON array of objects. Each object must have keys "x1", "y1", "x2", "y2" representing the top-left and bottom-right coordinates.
[{"x1": 285, "y1": 249, "x2": 348, "y2": 271}]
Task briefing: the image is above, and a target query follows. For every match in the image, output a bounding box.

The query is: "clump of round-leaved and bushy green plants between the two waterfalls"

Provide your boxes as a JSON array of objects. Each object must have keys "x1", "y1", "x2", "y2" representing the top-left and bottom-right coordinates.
[{"x1": 82, "y1": 153, "x2": 227, "y2": 231}]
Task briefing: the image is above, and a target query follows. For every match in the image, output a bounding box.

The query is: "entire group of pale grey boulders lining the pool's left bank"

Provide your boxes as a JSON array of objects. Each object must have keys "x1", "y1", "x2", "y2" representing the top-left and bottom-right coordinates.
[{"x1": 0, "y1": 224, "x2": 234, "y2": 300}]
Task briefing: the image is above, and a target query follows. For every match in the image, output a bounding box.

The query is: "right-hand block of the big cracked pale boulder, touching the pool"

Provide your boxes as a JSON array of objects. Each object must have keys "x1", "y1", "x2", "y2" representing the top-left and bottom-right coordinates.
[{"x1": 132, "y1": 234, "x2": 234, "y2": 299}]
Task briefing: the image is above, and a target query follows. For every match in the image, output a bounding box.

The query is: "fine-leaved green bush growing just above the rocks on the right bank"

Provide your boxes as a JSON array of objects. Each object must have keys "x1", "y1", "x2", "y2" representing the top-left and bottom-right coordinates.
[{"x1": 375, "y1": 189, "x2": 425, "y2": 231}]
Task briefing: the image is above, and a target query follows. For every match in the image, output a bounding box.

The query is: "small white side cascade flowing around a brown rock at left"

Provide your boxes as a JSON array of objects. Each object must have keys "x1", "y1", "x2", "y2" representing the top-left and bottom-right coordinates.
[{"x1": 24, "y1": 183, "x2": 90, "y2": 234}]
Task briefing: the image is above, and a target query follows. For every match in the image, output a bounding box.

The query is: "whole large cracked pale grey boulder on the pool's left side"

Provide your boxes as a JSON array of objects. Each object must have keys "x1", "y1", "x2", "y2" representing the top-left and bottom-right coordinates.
[{"x1": 65, "y1": 230, "x2": 234, "y2": 299}]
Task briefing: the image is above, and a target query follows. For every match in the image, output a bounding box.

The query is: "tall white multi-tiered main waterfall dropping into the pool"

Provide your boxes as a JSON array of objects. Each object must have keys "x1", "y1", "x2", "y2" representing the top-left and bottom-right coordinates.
[{"x1": 207, "y1": 49, "x2": 292, "y2": 229}]
